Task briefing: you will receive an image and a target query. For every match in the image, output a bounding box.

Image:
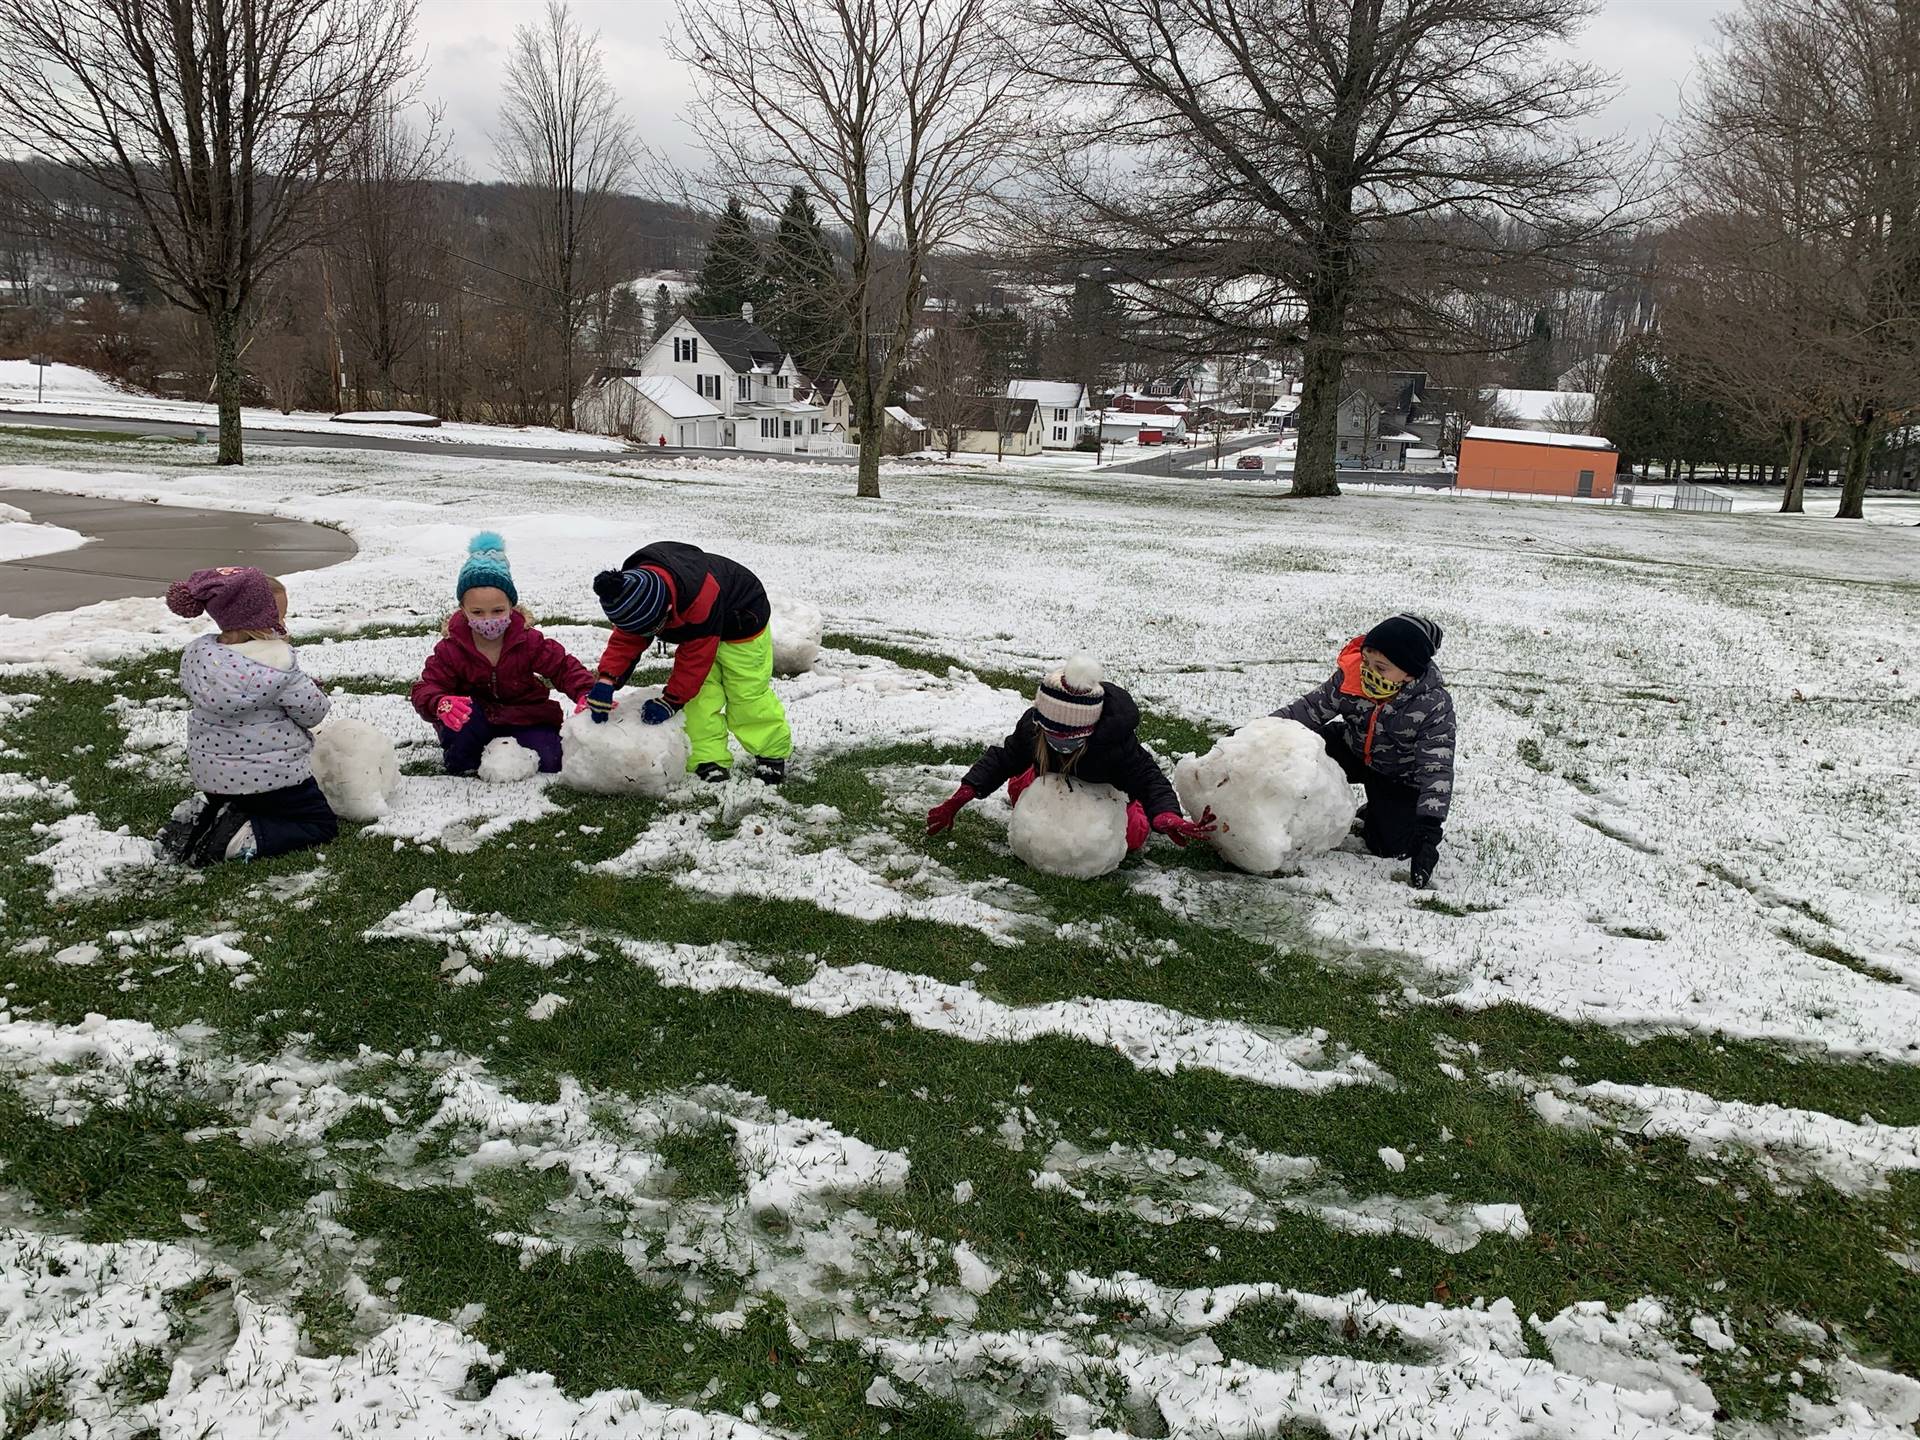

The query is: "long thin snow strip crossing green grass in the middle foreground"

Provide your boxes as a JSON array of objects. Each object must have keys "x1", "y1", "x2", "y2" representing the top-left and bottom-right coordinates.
[{"x1": 620, "y1": 941, "x2": 1380, "y2": 1092}]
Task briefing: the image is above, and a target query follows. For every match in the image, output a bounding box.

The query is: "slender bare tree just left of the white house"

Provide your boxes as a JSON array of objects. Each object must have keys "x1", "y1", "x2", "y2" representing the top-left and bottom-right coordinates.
[{"x1": 493, "y1": 0, "x2": 634, "y2": 430}]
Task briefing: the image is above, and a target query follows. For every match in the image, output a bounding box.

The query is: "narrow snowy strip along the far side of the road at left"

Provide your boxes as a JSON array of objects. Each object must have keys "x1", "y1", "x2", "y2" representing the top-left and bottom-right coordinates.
[{"x1": 0, "y1": 359, "x2": 632, "y2": 453}]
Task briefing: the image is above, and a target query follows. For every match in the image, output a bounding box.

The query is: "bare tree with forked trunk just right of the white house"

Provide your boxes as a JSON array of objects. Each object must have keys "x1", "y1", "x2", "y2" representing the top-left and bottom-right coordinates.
[{"x1": 674, "y1": 0, "x2": 1021, "y2": 497}]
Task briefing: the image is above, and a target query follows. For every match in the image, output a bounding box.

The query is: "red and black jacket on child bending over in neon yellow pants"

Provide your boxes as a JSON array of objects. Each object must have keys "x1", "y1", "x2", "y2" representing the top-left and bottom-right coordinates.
[{"x1": 599, "y1": 540, "x2": 772, "y2": 705}]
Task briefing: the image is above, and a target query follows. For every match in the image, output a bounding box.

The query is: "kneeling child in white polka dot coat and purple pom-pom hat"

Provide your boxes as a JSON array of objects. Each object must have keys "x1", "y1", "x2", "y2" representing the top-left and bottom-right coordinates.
[{"x1": 159, "y1": 566, "x2": 340, "y2": 866}]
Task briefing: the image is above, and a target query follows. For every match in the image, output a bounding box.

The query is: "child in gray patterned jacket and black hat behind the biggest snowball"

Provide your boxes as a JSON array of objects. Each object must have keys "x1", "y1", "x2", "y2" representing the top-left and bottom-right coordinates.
[{"x1": 1273, "y1": 614, "x2": 1453, "y2": 891}]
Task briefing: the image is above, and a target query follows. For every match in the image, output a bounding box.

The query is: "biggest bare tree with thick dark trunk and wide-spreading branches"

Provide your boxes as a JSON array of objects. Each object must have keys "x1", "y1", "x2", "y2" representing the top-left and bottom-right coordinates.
[{"x1": 1023, "y1": 0, "x2": 1624, "y2": 495}]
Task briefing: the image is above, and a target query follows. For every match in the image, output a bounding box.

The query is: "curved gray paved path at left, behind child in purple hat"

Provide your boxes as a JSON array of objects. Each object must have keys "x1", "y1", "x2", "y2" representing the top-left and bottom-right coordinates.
[{"x1": 0, "y1": 490, "x2": 355, "y2": 618}]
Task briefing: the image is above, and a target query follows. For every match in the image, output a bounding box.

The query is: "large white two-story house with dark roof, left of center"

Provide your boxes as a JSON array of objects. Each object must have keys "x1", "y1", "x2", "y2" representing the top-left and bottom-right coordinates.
[{"x1": 576, "y1": 305, "x2": 841, "y2": 453}]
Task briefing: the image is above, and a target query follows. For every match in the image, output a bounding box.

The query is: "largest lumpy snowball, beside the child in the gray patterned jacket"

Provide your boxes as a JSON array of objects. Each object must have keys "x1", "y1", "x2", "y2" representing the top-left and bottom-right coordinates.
[{"x1": 1173, "y1": 716, "x2": 1356, "y2": 876}]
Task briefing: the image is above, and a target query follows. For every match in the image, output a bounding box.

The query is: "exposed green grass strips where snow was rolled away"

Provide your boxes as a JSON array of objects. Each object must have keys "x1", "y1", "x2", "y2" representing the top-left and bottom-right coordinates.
[{"x1": 0, "y1": 652, "x2": 1920, "y2": 1436}]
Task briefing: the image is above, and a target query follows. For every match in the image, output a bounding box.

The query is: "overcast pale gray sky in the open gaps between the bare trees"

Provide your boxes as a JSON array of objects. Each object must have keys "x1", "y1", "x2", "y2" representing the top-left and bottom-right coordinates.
[{"x1": 420, "y1": 0, "x2": 1734, "y2": 180}]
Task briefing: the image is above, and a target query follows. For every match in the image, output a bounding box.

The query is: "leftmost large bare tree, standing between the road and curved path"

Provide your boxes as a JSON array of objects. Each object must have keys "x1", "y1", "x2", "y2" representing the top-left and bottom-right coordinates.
[{"x1": 0, "y1": 0, "x2": 415, "y2": 465}]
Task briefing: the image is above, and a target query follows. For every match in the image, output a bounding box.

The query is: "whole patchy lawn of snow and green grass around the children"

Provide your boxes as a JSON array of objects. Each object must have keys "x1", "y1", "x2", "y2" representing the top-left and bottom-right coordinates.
[{"x1": 0, "y1": 433, "x2": 1920, "y2": 1440}]
